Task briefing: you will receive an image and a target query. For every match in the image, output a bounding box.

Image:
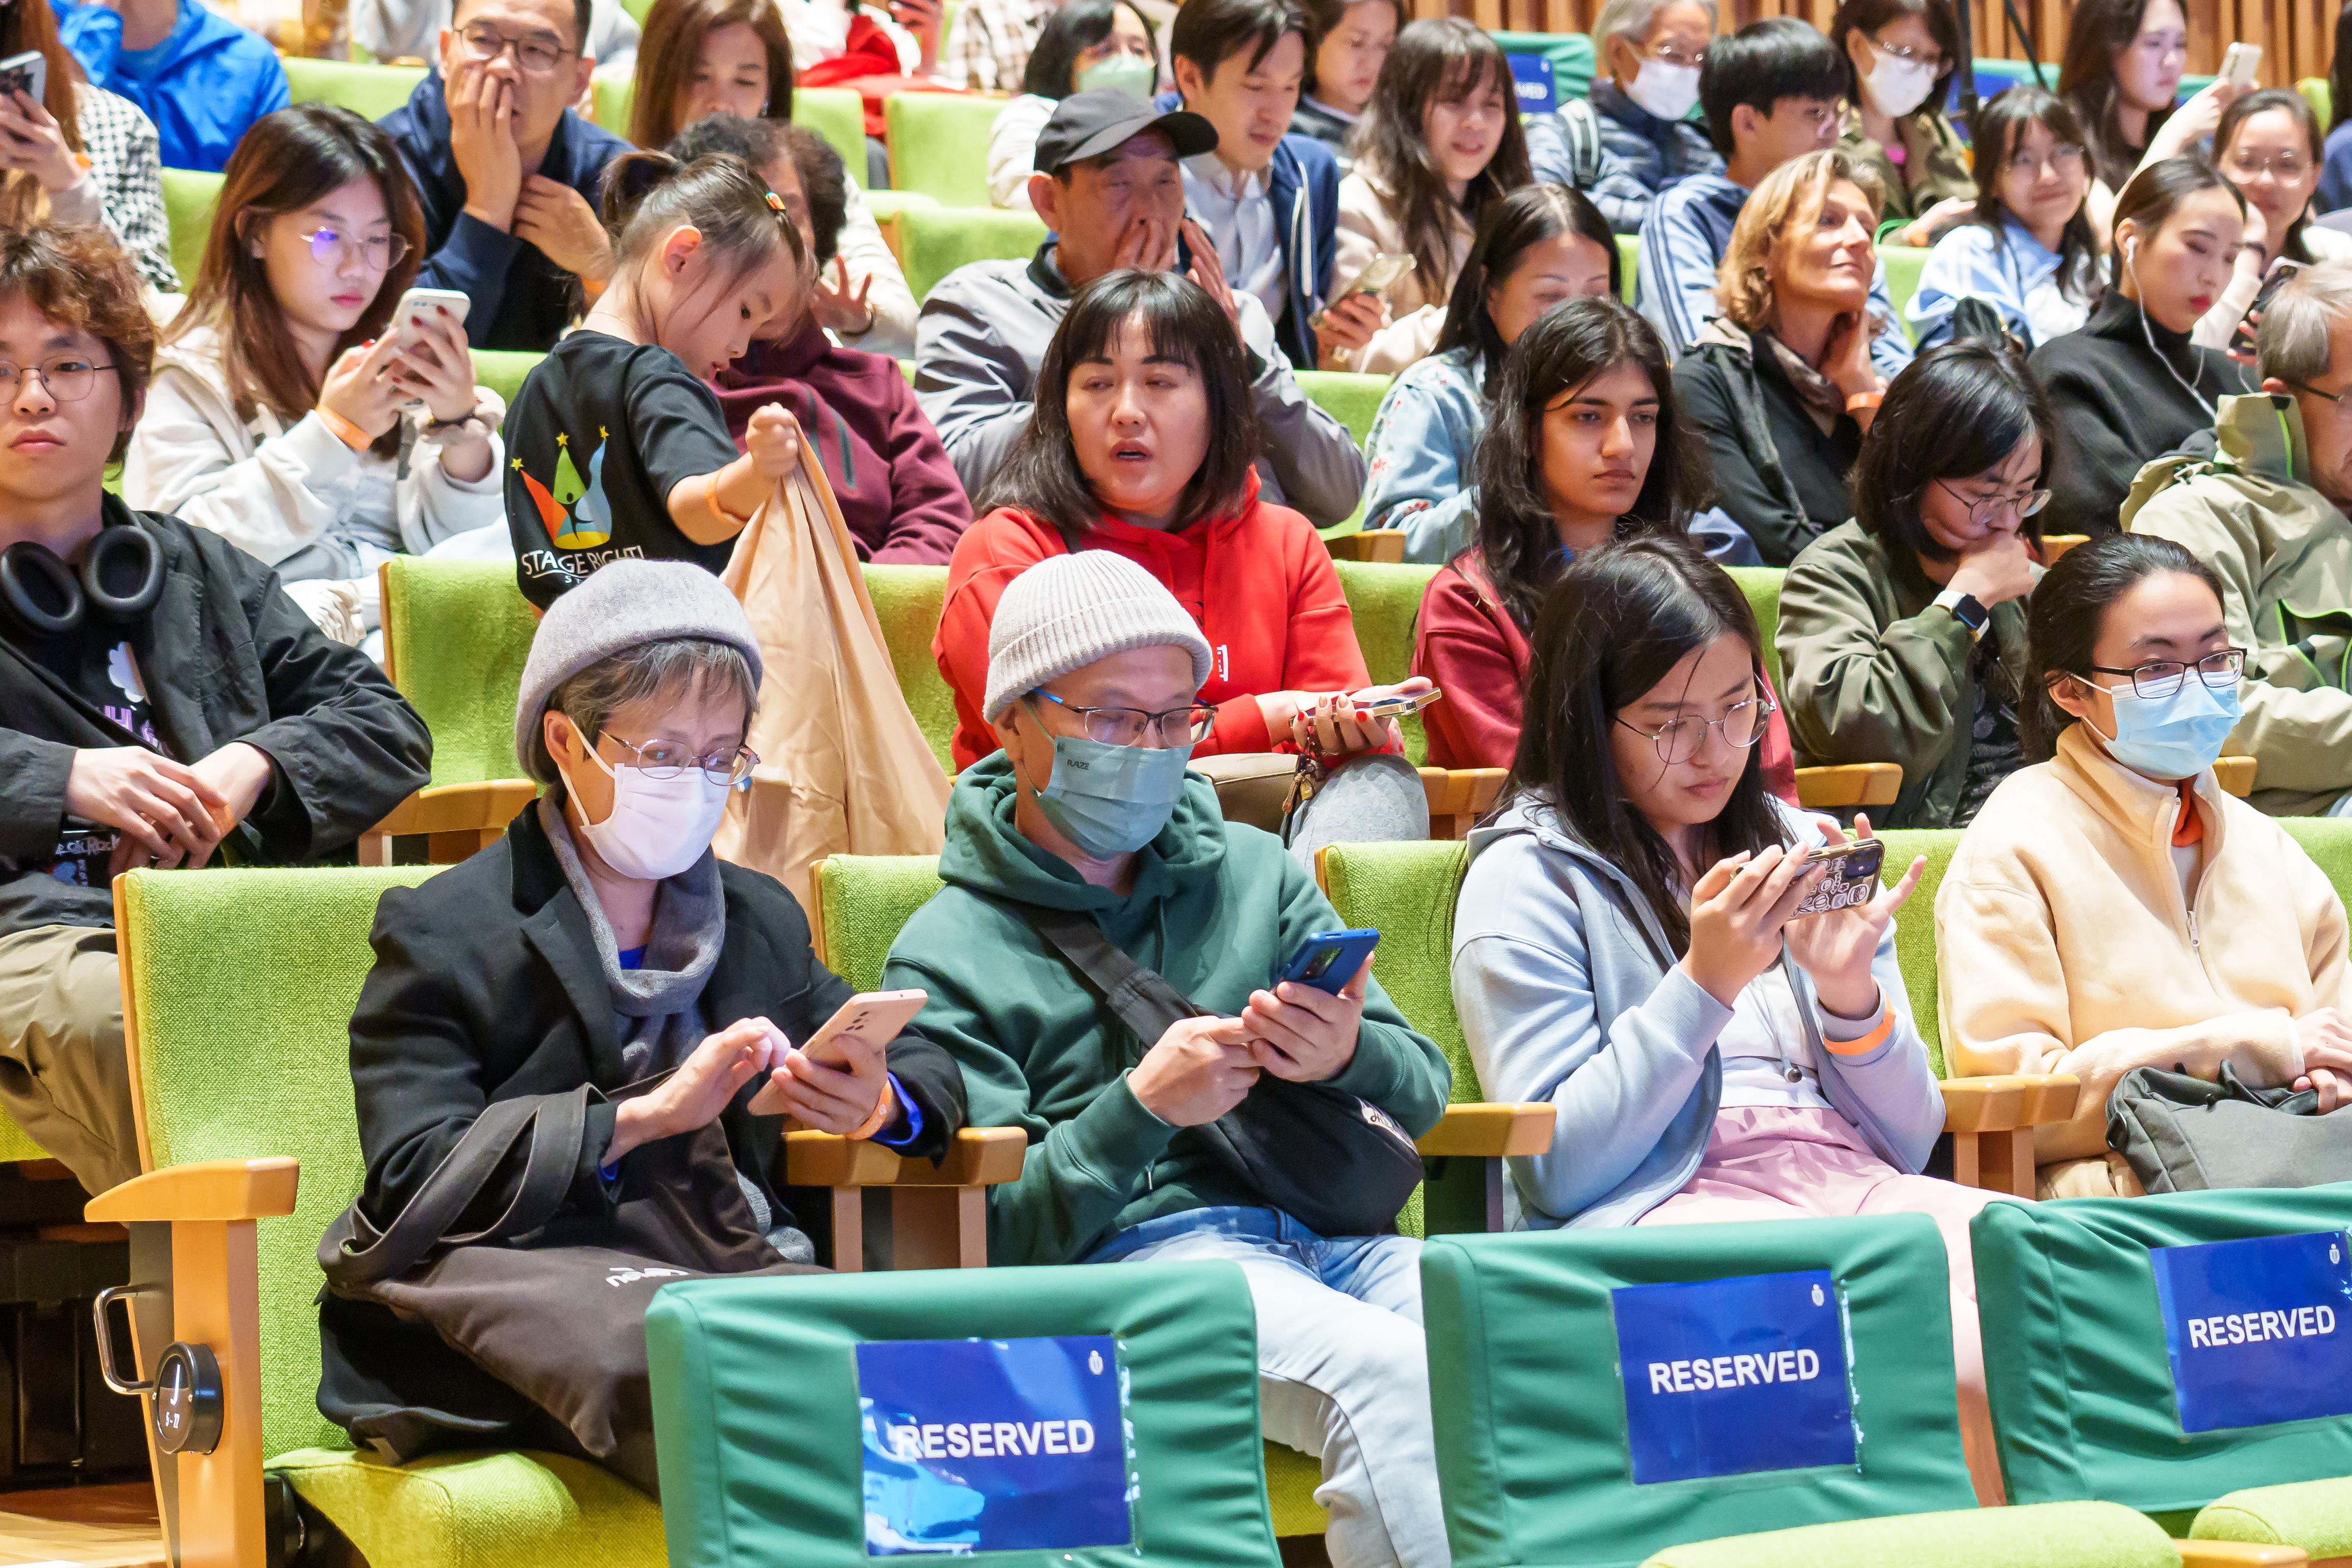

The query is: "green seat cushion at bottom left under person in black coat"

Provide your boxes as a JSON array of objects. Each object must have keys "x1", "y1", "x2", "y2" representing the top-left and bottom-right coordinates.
[{"x1": 271, "y1": 1448, "x2": 666, "y2": 1568}]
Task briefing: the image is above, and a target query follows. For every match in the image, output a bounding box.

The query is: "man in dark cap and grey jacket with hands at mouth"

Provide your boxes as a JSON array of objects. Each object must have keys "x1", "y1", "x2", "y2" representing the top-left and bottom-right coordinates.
[{"x1": 915, "y1": 89, "x2": 1364, "y2": 527}]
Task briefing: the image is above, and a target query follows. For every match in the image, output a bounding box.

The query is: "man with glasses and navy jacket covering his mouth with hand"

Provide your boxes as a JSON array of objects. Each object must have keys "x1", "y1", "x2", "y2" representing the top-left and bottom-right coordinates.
[{"x1": 383, "y1": 0, "x2": 630, "y2": 353}]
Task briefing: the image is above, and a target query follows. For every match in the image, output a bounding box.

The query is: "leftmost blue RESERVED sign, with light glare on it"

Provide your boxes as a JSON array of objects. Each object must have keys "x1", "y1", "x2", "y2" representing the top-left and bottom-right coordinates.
[{"x1": 856, "y1": 1335, "x2": 1136, "y2": 1556}]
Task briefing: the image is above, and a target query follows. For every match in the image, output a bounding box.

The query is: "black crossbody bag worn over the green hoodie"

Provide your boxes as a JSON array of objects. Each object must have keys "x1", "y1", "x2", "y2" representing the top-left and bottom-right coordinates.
[{"x1": 1025, "y1": 905, "x2": 1420, "y2": 1237}]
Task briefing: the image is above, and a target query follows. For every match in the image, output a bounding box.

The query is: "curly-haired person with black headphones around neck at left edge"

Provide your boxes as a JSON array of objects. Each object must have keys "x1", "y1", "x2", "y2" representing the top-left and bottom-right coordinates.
[{"x1": 0, "y1": 226, "x2": 433, "y2": 1192}]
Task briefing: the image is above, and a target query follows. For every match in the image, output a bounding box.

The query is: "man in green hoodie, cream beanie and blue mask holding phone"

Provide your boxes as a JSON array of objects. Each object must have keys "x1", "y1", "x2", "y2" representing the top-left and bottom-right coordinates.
[{"x1": 885, "y1": 550, "x2": 1451, "y2": 1568}]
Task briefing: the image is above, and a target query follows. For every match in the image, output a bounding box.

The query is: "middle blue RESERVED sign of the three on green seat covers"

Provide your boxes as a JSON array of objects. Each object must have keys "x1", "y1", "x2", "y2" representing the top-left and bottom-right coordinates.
[{"x1": 1609, "y1": 1269, "x2": 1853, "y2": 1483}]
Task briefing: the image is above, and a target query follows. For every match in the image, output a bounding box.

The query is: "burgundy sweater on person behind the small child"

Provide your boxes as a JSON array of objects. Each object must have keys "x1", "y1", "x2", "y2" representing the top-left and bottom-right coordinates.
[{"x1": 717, "y1": 315, "x2": 971, "y2": 567}]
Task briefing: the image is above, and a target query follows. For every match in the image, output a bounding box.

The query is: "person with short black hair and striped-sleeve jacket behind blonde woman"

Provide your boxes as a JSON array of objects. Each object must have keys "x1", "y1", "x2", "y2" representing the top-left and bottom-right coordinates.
[{"x1": 1635, "y1": 16, "x2": 1910, "y2": 376}]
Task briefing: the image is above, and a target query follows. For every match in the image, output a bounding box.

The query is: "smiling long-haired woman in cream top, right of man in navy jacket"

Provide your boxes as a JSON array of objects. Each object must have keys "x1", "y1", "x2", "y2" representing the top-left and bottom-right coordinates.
[{"x1": 1322, "y1": 16, "x2": 1533, "y2": 374}]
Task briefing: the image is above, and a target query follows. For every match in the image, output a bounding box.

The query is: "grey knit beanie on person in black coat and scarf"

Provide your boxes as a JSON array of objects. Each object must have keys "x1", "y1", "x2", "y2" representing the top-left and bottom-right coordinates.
[{"x1": 515, "y1": 559, "x2": 760, "y2": 757}]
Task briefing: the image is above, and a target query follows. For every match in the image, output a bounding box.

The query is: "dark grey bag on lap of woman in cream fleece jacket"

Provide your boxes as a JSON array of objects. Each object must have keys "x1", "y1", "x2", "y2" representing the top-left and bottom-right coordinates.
[{"x1": 2108, "y1": 1063, "x2": 2352, "y2": 1192}]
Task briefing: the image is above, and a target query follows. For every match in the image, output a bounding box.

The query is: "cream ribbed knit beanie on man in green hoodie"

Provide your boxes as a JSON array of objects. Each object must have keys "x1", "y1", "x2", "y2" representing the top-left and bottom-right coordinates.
[{"x1": 981, "y1": 550, "x2": 1211, "y2": 724}]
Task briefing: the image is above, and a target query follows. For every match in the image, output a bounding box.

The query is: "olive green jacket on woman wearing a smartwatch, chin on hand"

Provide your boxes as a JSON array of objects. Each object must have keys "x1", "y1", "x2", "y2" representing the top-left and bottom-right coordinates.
[{"x1": 1778, "y1": 522, "x2": 2025, "y2": 827}]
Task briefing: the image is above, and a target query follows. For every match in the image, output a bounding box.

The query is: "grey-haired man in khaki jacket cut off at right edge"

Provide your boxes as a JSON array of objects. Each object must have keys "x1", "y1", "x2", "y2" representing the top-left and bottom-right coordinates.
[{"x1": 2121, "y1": 261, "x2": 2352, "y2": 816}]
